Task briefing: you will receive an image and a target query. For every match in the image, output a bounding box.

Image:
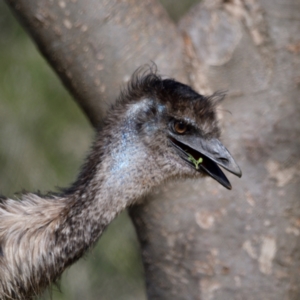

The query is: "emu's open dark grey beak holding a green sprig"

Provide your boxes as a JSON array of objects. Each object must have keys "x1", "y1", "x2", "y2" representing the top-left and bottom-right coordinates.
[{"x1": 171, "y1": 135, "x2": 242, "y2": 189}]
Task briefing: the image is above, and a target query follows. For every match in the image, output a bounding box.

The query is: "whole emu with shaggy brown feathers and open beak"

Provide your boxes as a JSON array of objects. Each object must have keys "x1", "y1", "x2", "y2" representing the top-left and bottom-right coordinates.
[{"x1": 0, "y1": 71, "x2": 241, "y2": 299}]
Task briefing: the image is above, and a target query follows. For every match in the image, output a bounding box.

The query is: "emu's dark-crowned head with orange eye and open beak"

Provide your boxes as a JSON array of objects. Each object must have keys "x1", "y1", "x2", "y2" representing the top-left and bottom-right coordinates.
[{"x1": 110, "y1": 73, "x2": 242, "y2": 189}]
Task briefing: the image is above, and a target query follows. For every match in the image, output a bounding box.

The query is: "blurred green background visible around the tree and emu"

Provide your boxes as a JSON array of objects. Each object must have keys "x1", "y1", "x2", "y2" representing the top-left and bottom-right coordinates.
[{"x1": 0, "y1": 0, "x2": 199, "y2": 300}]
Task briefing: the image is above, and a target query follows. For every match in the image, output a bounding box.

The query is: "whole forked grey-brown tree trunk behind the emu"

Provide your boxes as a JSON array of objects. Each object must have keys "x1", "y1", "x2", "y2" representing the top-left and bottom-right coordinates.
[{"x1": 7, "y1": 0, "x2": 300, "y2": 300}]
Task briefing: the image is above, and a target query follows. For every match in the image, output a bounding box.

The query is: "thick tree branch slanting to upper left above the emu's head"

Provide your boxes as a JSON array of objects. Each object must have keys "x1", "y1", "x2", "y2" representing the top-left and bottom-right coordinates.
[{"x1": 7, "y1": 0, "x2": 185, "y2": 126}]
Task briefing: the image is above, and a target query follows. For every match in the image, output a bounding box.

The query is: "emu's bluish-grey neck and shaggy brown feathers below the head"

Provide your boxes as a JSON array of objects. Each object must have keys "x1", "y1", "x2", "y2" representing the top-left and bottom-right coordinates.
[{"x1": 0, "y1": 111, "x2": 162, "y2": 299}]
